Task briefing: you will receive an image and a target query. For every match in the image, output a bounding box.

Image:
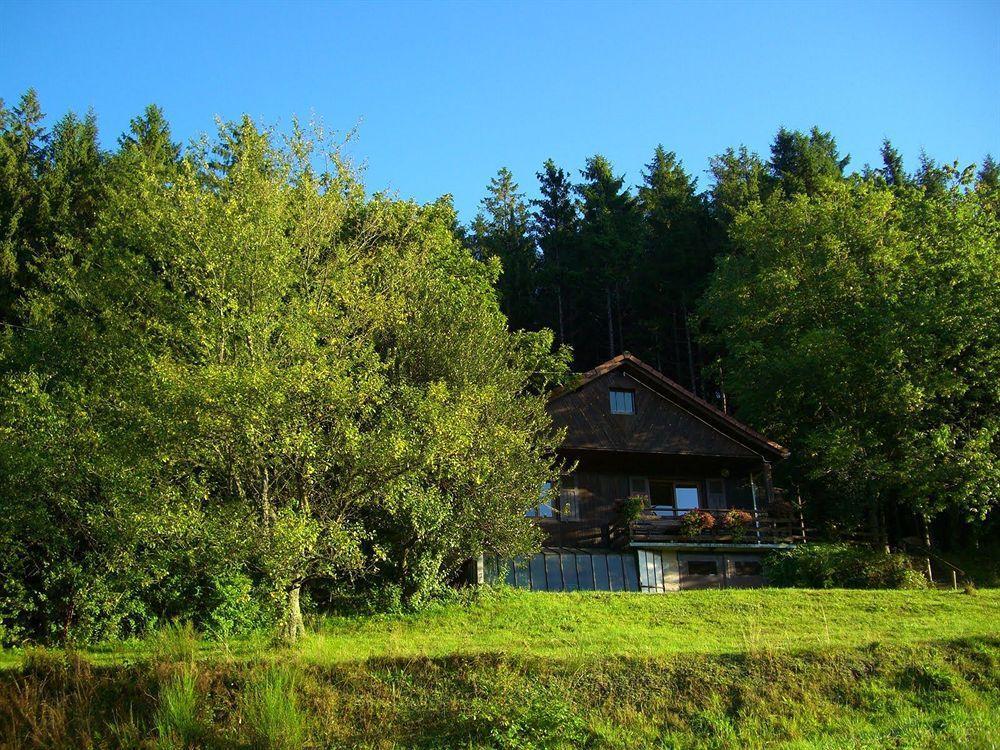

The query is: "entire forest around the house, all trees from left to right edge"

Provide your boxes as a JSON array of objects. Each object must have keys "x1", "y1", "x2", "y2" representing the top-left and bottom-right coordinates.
[{"x1": 0, "y1": 92, "x2": 1000, "y2": 644}]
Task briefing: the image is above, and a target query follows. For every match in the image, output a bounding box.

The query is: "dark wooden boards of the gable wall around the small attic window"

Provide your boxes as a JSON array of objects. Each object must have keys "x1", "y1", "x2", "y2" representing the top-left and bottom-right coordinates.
[{"x1": 549, "y1": 370, "x2": 758, "y2": 458}]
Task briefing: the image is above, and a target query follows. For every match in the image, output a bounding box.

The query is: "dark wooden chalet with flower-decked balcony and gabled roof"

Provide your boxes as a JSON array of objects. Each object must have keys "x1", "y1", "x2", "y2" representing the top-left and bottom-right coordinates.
[{"x1": 482, "y1": 353, "x2": 805, "y2": 592}]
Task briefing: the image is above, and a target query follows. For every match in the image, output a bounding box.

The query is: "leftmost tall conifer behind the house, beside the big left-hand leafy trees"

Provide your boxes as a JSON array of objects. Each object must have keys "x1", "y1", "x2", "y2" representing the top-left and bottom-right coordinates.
[{"x1": 471, "y1": 167, "x2": 538, "y2": 330}]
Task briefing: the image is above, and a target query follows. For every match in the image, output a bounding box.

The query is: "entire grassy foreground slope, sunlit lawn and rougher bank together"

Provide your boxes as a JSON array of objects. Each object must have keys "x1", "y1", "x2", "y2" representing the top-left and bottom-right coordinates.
[{"x1": 0, "y1": 590, "x2": 1000, "y2": 748}]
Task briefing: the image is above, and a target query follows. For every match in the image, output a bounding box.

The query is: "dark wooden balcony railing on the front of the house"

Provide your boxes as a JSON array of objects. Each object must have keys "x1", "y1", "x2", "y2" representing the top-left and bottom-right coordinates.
[{"x1": 623, "y1": 509, "x2": 806, "y2": 544}]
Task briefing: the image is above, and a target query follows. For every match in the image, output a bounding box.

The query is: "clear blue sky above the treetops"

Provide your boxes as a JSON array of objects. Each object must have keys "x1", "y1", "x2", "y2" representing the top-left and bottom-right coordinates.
[{"x1": 0, "y1": 0, "x2": 1000, "y2": 221}]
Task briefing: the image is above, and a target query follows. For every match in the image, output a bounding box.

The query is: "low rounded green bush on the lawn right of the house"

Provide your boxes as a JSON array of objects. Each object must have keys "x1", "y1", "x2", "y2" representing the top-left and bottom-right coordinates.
[{"x1": 764, "y1": 544, "x2": 927, "y2": 589}]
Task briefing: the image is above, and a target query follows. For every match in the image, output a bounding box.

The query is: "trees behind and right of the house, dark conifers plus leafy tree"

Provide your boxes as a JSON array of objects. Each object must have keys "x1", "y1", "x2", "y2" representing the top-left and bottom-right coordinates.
[{"x1": 467, "y1": 128, "x2": 1000, "y2": 545}]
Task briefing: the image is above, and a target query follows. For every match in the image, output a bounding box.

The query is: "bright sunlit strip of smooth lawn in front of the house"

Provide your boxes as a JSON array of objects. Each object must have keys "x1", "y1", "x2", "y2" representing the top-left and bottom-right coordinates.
[{"x1": 302, "y1": 589, "x2": 1000, "y2": 663}]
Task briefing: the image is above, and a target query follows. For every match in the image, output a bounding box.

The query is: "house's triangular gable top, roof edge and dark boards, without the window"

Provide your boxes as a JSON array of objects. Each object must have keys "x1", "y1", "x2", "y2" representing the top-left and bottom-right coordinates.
[{"x1": 549, "y1": 353, "x2": 788, "y2": 460}]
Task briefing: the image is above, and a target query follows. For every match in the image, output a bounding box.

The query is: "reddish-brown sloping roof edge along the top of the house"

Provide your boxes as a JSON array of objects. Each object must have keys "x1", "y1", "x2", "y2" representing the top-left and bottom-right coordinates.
[{"x1": 549, "y1": 352, "x2": 789, "y2": 459}]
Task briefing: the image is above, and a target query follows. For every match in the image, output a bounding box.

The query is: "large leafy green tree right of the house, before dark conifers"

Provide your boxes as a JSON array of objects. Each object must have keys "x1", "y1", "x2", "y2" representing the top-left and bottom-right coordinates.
[{"x1": 703, "y1": 179, "x2": 1000, "y2": 532}]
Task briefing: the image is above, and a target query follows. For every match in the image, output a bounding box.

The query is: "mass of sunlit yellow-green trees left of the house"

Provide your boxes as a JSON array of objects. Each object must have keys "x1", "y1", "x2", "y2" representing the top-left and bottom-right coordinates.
[{"x1": 0, "y1": 93, "x2": 567, "y2": 643}]
